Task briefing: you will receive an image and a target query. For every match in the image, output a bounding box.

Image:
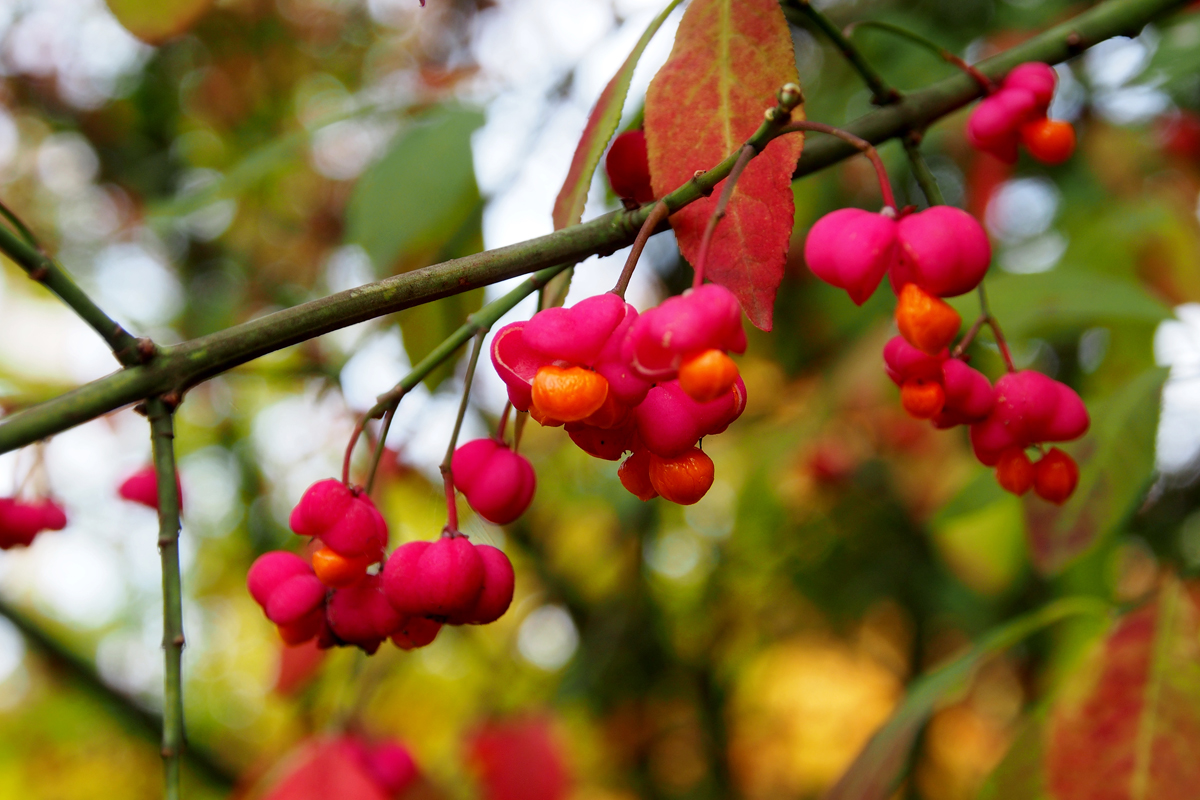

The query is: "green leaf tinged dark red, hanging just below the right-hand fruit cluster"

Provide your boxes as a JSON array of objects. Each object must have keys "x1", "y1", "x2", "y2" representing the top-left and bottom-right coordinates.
[{"x1": 1025, "y1": 367, "x2": 1166, "y2": 573}]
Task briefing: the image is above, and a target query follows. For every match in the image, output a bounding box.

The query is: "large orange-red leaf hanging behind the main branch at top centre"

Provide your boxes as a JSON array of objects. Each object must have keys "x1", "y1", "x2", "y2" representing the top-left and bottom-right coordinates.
[{"x1": 646, "y1": 0, "x2": 803, "y2": 331}]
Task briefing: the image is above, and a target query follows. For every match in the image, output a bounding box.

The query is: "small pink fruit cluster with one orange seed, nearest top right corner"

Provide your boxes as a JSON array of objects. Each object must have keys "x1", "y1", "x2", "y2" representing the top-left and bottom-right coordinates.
[{"x1": 967, "y1": 61, "x2": 1075, "y2": 164}]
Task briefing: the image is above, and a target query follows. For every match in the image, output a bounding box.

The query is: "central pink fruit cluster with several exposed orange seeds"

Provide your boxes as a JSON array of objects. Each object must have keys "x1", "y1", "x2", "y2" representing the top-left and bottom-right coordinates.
[{"x1": 487, "y1": 284, "x2": 746, "y2": 506}]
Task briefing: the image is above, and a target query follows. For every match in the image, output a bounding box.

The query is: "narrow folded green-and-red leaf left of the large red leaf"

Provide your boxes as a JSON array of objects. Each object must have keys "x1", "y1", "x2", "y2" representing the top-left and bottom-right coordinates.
[{"x1": 554, "y1": 0, "x2": 682, "y2": 230}]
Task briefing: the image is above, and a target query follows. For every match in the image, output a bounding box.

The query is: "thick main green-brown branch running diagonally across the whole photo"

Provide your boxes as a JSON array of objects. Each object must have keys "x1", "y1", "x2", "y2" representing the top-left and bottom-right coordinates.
[{"x1": 0, "y1": 0, "x2": 1186, "y2": 452}]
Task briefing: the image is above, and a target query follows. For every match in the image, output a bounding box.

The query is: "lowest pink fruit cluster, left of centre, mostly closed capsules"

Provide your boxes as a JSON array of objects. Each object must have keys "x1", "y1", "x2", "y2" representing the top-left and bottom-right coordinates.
[{"x1": 246, "y1": 479, "x2": 514, "y2": 652}]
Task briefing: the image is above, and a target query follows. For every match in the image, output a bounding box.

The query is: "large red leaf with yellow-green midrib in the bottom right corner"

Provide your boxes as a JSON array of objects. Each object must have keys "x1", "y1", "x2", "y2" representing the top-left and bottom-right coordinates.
[{"x1": 1045, "y1": 579, "x2": 1200, "y2": 800}]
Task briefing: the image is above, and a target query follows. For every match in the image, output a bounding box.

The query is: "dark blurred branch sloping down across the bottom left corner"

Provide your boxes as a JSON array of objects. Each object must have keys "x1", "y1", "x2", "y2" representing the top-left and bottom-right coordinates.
[{"x1": 0, "y1": 600, "x2": 238, "y2": 788}]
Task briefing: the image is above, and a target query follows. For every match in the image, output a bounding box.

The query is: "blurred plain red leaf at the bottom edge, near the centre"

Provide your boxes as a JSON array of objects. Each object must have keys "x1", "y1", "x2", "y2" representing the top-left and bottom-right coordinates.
[{"x1": 468, "y1": 717, "x2": 571, "y2": 800}]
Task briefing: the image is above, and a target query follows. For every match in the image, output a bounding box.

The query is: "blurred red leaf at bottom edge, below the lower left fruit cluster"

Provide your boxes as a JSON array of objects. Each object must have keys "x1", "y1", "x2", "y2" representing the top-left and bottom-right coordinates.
[{"x1": 263, "y1": 739, "x2": 389, "y2": 800}]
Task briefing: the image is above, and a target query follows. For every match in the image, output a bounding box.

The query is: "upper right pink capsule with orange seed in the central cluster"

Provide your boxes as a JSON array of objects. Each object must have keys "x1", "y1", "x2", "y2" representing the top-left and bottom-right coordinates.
[{"x1": 620, "y1": 283, "x2": 746, "y2": 380}]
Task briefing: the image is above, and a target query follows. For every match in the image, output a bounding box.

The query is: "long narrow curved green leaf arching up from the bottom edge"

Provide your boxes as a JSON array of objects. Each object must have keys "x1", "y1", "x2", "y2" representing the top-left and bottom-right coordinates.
[{"x1": 824, "y1": 597, "x2": 1105, "y2": 800}]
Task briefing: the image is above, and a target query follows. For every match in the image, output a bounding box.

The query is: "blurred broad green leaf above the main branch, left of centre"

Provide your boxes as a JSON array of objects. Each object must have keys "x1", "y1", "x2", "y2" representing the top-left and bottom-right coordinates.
[{"x1": 346, "y1": 109, "x2": 484, "y2": 275}]
